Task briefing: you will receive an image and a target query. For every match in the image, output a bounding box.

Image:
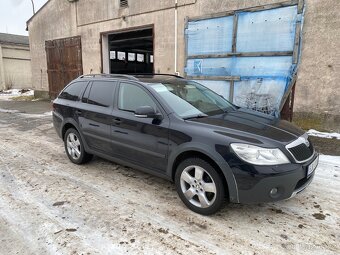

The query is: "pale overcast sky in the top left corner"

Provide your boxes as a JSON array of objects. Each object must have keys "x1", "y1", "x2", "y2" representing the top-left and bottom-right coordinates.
[{"x1": 0, "y1": 0, "x2": 47, "y2": 35}]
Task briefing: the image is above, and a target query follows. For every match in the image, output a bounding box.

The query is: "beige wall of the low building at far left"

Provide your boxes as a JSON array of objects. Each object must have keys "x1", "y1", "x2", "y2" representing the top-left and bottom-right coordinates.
[{"x1": 0, "y1": 44, "x2": 32, "y2": 89}]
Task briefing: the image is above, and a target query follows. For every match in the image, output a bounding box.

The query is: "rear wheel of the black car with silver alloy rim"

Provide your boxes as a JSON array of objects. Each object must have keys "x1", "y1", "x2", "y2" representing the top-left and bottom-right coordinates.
[{"x1": 64, "y1": 128, "x2": 93, "y2": 165}]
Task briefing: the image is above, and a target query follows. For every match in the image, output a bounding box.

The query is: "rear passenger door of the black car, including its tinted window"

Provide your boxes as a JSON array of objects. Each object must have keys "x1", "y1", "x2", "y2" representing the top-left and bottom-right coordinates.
[{"x1": 77, "y1": 81, "x2": 117, "y2": 155}]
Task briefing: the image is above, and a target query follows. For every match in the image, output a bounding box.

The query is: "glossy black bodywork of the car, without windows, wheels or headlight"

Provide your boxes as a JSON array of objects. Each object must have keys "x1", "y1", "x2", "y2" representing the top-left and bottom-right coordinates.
[{"x1": 53, "y1": 78, "x2": 317, "y2": 203}]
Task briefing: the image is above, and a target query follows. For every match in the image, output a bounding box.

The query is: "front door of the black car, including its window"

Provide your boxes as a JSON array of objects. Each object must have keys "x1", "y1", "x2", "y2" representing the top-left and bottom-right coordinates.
[{"x1": 111, "y1": 81, "x2": 169, "y2": 172}]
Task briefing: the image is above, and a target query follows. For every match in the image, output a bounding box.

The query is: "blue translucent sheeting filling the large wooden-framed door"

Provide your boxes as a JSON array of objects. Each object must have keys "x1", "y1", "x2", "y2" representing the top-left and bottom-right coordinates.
[{"x1": 185, "y1": 5, "x2": 303, "y2": 114}]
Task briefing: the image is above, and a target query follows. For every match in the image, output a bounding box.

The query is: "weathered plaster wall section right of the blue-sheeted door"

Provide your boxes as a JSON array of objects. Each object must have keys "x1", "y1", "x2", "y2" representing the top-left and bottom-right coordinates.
[{"x1": 295, "y1": 0, "x2": 340, "y2": 115}]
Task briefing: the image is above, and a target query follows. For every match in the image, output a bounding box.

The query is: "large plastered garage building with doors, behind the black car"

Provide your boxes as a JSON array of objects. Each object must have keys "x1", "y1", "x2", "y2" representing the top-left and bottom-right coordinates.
[{"x1": 27, "y1": 0, "x2": 340, "y2": 121}]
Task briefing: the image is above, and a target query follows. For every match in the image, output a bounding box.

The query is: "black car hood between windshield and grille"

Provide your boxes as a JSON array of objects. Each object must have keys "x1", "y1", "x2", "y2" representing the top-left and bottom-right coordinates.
[{"x1": 191, "y1": 108, "x2": 305, "y2": 143}]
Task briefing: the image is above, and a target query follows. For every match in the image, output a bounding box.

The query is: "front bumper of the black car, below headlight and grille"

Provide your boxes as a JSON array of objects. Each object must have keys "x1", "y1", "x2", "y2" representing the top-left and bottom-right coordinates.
[{"x1": 232, "y1": 153, "x2": 318, "y2": 204}]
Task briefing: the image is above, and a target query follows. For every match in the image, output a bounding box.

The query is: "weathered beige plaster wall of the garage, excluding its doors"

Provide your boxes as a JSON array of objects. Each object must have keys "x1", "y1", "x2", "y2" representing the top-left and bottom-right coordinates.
[{"x1": 28, "y1": 0, "x2": 340, "y2": 114}]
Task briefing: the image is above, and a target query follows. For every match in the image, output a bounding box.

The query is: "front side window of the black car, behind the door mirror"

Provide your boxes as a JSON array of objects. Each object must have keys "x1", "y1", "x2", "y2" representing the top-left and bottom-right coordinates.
[{"x1": 118, "y1": 82, "x2": 157, "y2": 112}]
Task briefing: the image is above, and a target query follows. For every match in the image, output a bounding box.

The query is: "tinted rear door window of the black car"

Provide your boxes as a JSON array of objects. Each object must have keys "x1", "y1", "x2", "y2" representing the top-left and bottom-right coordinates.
[{"x1": 82, "y1": 81, "x2": 116, "y2": 107}]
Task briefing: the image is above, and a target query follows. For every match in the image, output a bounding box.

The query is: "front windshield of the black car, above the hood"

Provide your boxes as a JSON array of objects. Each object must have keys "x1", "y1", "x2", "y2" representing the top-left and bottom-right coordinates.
[{"x1": 150, "y1": 80, "x2": 234, "y2": 119}]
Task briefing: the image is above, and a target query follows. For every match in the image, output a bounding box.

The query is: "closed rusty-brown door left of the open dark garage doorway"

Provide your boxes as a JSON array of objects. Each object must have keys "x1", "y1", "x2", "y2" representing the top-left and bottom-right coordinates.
[{"x1": 45, "y1": 36, "x2": 83, "y2": 98}]
